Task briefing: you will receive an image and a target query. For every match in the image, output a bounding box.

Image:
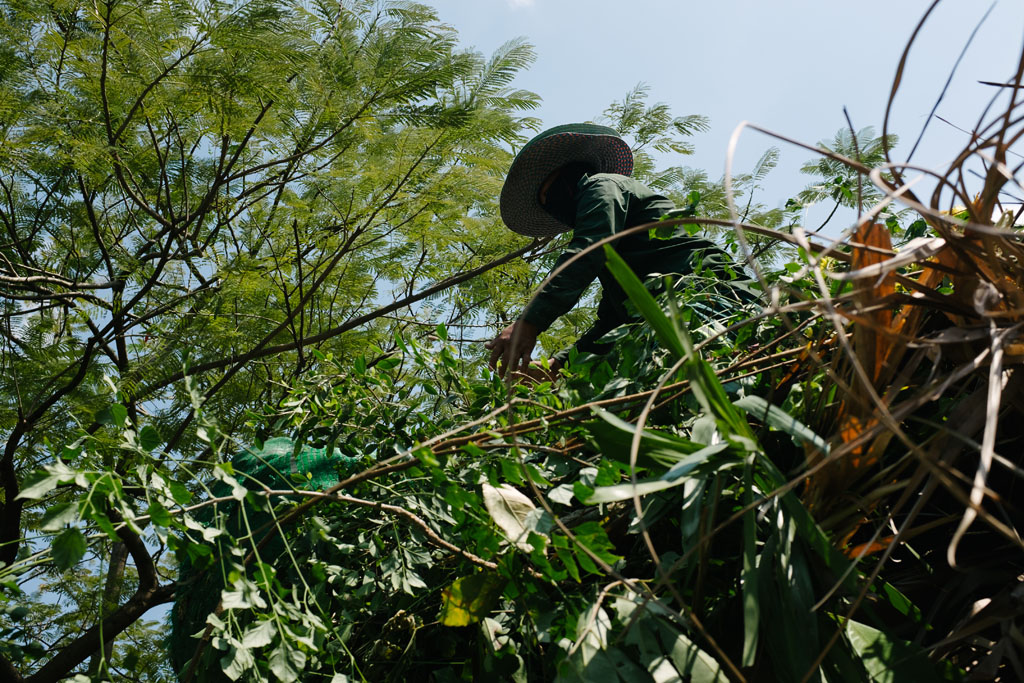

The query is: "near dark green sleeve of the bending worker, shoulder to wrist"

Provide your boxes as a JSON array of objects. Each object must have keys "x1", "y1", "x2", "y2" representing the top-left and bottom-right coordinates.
[{"x1": 522, "y1": 178, "x2": 629, "y2": 331}]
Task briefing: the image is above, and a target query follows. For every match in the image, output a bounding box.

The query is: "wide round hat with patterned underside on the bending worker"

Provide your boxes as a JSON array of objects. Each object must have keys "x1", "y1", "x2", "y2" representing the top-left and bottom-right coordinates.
[{"x1": 499, "y1": 123, "x2": 633, "y2": 238}]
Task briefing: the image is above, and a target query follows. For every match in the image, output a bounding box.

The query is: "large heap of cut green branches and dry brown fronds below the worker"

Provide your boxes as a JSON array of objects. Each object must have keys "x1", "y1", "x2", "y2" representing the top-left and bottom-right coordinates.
[{"x1": 174, "y1": 13, "x2": 1024, "y2": 683}]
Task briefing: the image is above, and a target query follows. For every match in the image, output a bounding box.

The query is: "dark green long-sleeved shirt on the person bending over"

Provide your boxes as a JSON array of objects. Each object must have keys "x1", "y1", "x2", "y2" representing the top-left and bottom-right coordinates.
[{"x1": 523, "y1": 173, "x2": 719, "y2": 331}]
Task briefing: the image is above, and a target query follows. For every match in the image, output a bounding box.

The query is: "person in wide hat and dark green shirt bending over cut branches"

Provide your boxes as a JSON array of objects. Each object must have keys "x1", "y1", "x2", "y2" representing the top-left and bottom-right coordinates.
[{"x1": 486, "y1": 123, "x2": 728, "y2": 377}]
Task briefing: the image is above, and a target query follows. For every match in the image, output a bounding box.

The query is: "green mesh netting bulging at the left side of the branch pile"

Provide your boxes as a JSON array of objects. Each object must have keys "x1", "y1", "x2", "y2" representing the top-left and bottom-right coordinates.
[{"x1": 168, "y1": 437, "x2": 359, "y2": 683}]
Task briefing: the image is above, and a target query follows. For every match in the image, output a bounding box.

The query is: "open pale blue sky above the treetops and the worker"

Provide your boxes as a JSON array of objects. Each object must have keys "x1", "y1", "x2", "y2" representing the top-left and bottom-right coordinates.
[{"x1": 425, "y1": 0, "x2": 1024, "y2": 227}]
